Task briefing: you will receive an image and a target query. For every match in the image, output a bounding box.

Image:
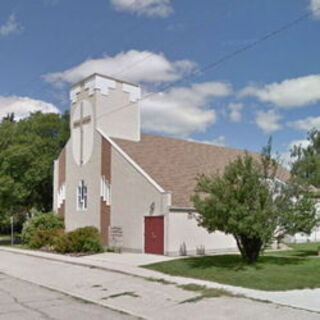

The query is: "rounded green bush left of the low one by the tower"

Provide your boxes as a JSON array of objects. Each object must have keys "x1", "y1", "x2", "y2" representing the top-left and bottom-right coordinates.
[{"x1": 21, "y1": 212, "x2": 64, "y2": 249}]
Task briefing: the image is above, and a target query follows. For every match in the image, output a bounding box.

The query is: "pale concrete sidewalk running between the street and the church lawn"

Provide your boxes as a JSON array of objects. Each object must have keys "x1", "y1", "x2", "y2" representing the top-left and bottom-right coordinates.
[{"x1": 0, "y1": 247, "x2": 320, "y2": 312}]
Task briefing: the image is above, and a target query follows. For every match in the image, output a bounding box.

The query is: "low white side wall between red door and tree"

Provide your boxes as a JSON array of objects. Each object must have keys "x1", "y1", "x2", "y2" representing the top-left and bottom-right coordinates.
[{"x1": 165, "y1": 212, "x2": 237, "y2": 256}]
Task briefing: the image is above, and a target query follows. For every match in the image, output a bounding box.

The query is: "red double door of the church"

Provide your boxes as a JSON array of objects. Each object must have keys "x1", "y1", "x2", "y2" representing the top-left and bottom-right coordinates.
[{"x1": 144, "y1": 216, "x2": 164, "y2": 254}]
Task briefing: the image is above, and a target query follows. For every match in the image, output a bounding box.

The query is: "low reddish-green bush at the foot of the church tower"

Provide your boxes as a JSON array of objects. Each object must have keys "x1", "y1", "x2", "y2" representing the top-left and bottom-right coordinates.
[{"x1": 53, "y1": 227, "x2": 103, "y2": 253}]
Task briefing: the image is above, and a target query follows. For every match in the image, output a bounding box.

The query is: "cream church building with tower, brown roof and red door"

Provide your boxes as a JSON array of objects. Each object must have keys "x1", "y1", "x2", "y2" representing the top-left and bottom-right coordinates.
[{"x1": 53, "y1": 74, "x2": 288, "y2": 256}]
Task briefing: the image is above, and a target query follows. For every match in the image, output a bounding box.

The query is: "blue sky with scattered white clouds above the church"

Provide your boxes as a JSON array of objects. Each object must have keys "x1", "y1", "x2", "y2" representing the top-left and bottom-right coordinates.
[{"x1": 0, "y1": 0, "x2": 320, "y2": 165}]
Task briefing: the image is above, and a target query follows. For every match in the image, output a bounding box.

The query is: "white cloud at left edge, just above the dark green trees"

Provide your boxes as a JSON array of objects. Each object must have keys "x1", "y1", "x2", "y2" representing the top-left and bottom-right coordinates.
[{"x1": 0, "y1": 96, "x2": 60, "y2": 120}]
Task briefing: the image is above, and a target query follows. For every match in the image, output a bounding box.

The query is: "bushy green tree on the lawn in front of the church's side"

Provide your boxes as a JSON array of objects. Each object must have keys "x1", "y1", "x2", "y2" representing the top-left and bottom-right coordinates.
[{"x1": 192, "y1": 142, "x2": 317, "y2": 263}]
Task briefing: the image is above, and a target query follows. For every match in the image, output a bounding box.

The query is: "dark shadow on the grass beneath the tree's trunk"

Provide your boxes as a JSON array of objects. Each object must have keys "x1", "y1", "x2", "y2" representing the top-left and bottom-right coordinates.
[{"x1": 185, "y1": 255, "x2": 304, "y2": 271}]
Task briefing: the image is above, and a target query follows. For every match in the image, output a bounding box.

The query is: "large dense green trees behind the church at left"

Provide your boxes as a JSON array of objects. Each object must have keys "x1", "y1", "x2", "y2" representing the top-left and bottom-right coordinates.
[{"x1": 0, "y1": 112, "x2": 69, "y2": 232}]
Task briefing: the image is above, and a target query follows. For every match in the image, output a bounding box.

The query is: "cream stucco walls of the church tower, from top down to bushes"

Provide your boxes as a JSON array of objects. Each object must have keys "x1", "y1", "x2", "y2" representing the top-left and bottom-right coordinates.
[{"x1": 65, "y1": 76, "x2": 140, "y2": 230}]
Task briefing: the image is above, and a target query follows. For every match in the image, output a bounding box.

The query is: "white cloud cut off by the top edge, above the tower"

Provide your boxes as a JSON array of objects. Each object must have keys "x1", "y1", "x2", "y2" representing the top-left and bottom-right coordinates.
[{"x1": 110, "y1": 0, "x2": 173, "y2": 18}]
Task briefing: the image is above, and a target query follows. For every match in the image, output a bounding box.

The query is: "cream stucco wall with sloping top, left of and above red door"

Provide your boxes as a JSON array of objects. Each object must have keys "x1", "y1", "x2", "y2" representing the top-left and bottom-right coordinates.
[{"x1": 111, "y1": 147, "x2": 168, "y2": 252}]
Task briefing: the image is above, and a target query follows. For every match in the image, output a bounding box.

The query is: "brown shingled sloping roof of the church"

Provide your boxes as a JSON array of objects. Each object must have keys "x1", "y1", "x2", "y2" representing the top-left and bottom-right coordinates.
[{"x1": 112, "y1": 134, "x2": 289, "y2": 207}]
